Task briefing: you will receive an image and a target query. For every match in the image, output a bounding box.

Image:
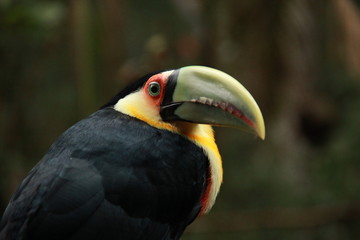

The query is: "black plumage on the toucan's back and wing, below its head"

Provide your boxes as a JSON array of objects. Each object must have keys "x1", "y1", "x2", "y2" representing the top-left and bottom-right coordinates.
[{"x1": 0, "y1": 107, "x2": 209, "y2": 240}]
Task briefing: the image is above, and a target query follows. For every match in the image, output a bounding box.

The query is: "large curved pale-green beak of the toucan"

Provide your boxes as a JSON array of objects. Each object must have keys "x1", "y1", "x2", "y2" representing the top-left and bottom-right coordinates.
[{"x1": 160, "y1": 66, "x2": 265, "y2": 139}]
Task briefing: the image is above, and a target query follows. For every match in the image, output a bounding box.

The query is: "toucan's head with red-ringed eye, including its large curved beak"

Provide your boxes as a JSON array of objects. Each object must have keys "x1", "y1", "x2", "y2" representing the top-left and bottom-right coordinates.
[{"x1": 106, "y1": 66, "x2": 265, "y2": 139}]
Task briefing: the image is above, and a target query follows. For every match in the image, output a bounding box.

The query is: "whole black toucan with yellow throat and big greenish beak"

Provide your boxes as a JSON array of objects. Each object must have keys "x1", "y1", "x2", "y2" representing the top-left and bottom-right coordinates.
[{"x1": 0, "y1": 66, "x2": 265, "y2": 240}]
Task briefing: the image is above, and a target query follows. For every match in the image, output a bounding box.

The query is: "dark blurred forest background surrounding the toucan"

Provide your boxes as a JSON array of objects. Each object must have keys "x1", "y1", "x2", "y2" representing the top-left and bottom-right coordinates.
[{"x1": 0, "y1": 0, "x2": 360, "y2": 240}]
